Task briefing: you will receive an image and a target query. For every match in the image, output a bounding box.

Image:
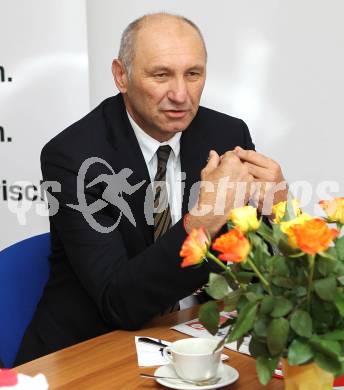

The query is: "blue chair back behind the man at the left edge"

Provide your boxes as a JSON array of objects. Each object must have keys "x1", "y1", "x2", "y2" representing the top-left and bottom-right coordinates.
[{"x1": 0, "y1": 233, "x2": 50, "y2": 368}]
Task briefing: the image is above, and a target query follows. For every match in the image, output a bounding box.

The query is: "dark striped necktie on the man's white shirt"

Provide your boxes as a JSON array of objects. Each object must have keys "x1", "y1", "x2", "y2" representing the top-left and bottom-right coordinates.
[{"x1": 153, "y1": 145, "x2": 172, "y2": 241}]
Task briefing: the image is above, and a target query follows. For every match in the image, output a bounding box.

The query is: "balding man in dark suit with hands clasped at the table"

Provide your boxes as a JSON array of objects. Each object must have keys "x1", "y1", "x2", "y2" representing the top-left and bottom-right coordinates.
[{"x1": 16, "y1": 14, "x2": 285, "y2": 364}]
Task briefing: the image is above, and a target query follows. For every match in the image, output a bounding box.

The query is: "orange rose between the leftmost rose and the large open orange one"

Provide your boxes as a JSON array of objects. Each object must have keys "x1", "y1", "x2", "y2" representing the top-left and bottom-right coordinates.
[{"x1": 213, "y1": 228, "x2": 251, "y2": 263}]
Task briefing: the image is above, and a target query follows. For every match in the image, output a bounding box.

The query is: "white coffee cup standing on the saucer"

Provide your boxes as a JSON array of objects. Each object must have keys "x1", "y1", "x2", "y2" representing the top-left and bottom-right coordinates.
[{"x1": 164, "y1": 338, "x2": 223, "y2": 381}]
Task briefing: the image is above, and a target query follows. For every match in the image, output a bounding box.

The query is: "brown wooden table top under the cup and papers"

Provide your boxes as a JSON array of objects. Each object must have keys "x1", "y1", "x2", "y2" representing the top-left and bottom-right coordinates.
[{"x1": 17, "y1": 308, "x2": 283, "y2": 390}]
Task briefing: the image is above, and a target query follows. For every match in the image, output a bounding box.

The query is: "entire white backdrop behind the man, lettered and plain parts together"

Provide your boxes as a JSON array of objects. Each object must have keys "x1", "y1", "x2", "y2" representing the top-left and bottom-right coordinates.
[{"x1": 0, "y1": 0, "x2": 344, "y2": 251}]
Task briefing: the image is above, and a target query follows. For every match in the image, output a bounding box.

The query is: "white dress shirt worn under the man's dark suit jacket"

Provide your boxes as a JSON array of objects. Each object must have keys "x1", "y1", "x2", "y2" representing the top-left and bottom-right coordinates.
[{"x1": 127, "y1": 112, "x2": 198, "y2": 309}]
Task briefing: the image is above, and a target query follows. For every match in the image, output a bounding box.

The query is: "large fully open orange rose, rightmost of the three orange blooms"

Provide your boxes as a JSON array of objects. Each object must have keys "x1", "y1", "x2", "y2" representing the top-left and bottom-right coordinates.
[{"x1": 291, "y1": 218, "x2": 339, "y2": 255}]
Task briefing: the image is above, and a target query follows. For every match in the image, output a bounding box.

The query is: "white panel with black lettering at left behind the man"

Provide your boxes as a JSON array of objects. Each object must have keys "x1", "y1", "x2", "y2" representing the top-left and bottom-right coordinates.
[{"x1": 0, "y1": 0, "x2": 89, "y2": 251}]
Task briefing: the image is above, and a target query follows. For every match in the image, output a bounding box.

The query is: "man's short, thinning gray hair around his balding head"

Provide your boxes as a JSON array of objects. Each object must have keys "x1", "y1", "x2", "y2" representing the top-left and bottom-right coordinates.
[{"x1": 118, "y1": 12, "x2": 207, "y2": 75}]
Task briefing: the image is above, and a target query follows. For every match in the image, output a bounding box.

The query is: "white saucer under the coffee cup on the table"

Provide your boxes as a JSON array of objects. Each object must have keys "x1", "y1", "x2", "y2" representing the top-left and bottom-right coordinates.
[{"x1": 154, "y1": 364, "x2": 239, "y2": 390}]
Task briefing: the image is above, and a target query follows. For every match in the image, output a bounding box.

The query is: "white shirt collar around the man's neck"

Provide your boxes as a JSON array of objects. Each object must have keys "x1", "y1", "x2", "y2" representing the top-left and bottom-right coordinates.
[{"x1": 127, "y1": 111, "x2": 182, "y2": 164}]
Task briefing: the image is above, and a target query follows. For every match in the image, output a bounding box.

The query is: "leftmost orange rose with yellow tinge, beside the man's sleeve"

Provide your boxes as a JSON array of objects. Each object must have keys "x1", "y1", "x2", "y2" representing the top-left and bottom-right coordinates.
[{"x1": 179, "y1": 227, "x2": 210, "y2": 268}]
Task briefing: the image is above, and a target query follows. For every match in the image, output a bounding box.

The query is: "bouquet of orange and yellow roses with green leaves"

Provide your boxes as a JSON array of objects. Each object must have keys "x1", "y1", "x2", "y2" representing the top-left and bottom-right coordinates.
[{"x1": 180, "y1": 198, "x2": 344, "y2": 384}]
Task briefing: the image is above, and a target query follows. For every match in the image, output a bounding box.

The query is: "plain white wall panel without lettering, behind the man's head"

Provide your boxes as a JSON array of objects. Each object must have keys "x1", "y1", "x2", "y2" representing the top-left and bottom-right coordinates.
[{"x1": 87, "y1": 0, "x2": 344, "y2": 212}]
